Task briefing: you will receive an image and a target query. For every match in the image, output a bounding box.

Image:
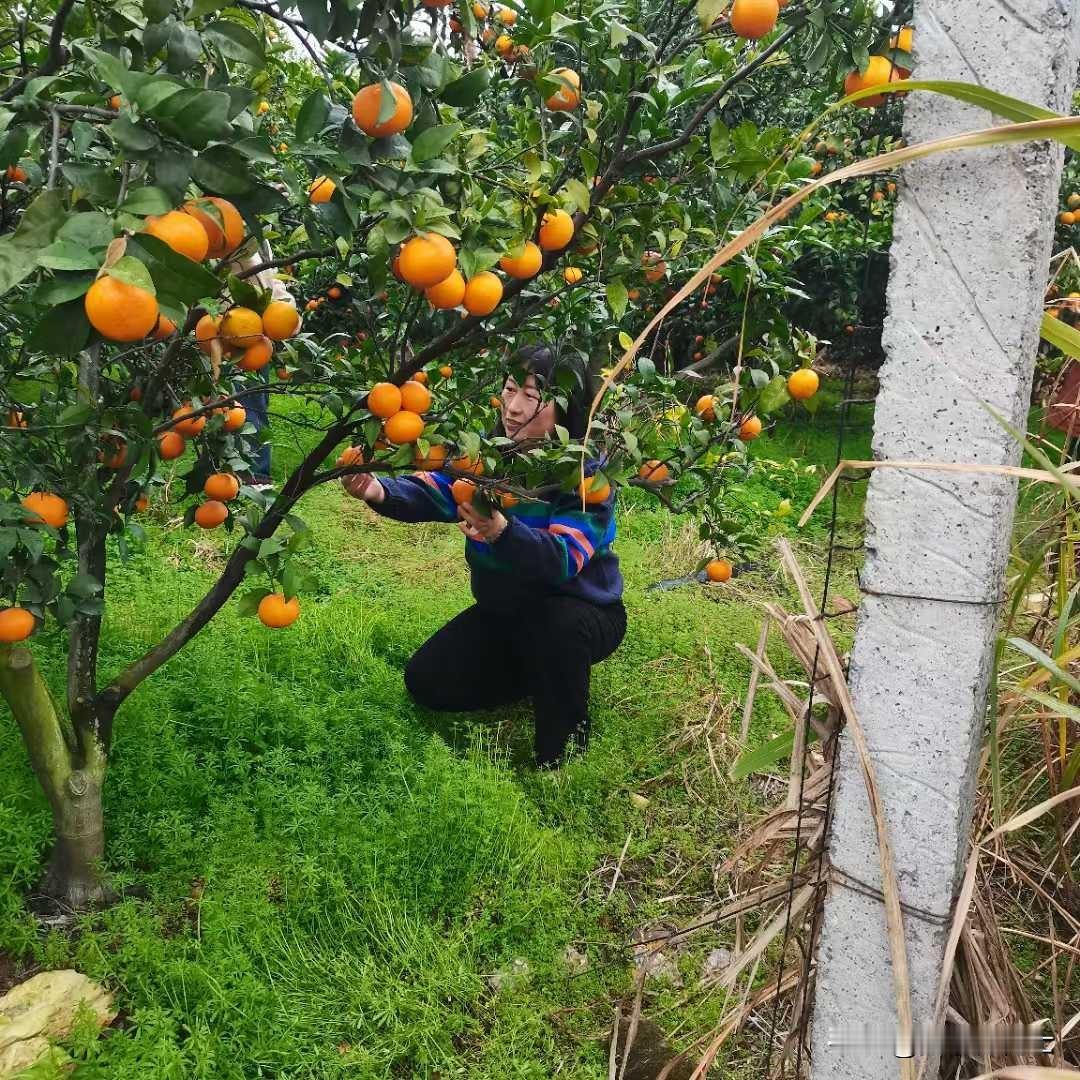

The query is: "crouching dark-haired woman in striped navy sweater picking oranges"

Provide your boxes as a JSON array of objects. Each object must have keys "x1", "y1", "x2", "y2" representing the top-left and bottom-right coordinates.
[{"x1": 342, "y1": 346, "x2": 626, "y2": 768}]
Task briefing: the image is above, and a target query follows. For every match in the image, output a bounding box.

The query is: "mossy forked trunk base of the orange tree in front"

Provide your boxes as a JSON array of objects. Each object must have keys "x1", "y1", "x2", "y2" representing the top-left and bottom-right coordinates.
[{"x1": 0, "y1": 646, "x2": 112, "y2": 910}]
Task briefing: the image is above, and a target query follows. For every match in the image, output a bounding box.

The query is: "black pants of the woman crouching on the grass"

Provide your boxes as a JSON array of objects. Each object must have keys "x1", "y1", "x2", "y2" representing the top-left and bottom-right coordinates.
[{"x1": 405, "y1": 596, "x2": 626, "y2": 766}]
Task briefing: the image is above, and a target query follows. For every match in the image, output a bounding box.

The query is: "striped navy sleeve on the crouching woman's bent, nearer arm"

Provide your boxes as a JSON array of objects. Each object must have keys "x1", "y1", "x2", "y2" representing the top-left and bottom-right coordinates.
[{"x1": 491, "y1": 492, "x2": 615, "y2": 584}]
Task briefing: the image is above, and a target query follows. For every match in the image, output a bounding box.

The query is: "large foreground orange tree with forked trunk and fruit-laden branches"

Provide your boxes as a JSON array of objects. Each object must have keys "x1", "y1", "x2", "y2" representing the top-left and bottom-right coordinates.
[{"x1": 0, "y1": 0, "x2": 889, "y2": 907}]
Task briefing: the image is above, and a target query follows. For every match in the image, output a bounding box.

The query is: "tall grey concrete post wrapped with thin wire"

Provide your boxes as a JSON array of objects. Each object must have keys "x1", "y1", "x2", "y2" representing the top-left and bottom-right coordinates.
[{"x1": 812, "y1": 0, "x2": 1080, "y2": 1080}]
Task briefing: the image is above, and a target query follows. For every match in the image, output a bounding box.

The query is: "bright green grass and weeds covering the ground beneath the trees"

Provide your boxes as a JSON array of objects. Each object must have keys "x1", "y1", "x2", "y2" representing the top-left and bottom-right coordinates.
[{"x1": 0, "y1": 384, "x2": 868, "y2": 1080}]
